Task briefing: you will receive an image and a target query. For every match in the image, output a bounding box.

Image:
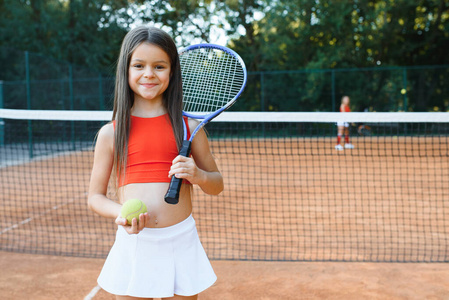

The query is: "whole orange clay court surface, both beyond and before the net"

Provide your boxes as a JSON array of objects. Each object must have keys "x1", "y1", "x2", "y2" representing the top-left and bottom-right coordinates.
[{"x1": 0, "y1": 136, "x2": 449, "y2": 299}]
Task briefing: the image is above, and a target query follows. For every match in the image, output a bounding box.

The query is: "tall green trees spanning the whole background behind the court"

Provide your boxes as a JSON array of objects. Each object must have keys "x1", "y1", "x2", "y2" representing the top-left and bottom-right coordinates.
[{"x1": 0, "y1": 0, "x2": 449, "y2": 111}]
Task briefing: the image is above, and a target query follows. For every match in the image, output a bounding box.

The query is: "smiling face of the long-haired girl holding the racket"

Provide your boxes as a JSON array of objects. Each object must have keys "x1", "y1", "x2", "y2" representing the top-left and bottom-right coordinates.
[{"x1": 128, "y1": 43, "x2": 171, "y2": 102}]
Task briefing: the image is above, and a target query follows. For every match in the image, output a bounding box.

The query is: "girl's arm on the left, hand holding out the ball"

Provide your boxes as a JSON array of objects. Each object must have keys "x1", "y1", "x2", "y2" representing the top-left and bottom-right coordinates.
[{"x1": 88, "y1": 123, "x2": 149, "y2": 233}]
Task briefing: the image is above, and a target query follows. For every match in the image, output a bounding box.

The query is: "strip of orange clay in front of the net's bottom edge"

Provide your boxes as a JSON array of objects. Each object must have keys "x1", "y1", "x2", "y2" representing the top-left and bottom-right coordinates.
[{"x1": 0, "y1": 252, "x2": 449, "y2": 300}]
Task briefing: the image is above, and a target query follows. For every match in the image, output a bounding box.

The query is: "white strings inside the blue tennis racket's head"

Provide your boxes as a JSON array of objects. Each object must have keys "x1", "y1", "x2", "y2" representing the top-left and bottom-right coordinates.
[{"x1": 180, "y1": 48, "x2": 244, "y2": 113}]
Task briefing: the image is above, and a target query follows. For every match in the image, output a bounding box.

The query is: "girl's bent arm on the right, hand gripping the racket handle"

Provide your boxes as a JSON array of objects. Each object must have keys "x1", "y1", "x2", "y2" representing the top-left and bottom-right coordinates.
[{"x1": 169, "y1": 119, "x2": 223, "y2": 195}]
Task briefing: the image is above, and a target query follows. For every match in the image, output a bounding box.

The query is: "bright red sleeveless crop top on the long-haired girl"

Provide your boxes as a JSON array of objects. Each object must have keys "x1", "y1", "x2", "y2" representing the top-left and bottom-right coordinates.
[{"x1": 114, "y1": 114, "x2": 190, "y2": 187}]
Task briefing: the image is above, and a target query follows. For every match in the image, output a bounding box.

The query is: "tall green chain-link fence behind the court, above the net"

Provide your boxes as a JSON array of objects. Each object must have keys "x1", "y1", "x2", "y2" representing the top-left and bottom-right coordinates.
[{"x1": 0, "y1": 48, "x2": 449, "y2": 111}]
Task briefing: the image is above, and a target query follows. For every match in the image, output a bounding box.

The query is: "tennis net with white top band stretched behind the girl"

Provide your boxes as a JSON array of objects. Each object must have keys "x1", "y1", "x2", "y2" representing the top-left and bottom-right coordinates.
[{"x1": 0, "y1": 109, "x2": 449, "y2": 262}]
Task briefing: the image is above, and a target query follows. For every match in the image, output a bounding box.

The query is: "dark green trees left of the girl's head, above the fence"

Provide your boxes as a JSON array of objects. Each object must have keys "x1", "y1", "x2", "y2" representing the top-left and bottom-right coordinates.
[{"x1": 0, "y1": 0, "x2": 126, "y2": 71}]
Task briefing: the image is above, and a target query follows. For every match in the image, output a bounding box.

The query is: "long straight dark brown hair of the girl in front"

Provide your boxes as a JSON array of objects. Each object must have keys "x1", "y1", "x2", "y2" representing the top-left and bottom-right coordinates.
[{"x1": 112, "y1": 26, "x2": 183, "y2": 188}]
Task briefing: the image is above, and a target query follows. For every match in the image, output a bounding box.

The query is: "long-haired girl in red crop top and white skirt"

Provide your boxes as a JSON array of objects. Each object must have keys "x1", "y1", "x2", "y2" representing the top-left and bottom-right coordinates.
[{"x1": 88, "y1": 27, "x2": 223, "y2": 299}]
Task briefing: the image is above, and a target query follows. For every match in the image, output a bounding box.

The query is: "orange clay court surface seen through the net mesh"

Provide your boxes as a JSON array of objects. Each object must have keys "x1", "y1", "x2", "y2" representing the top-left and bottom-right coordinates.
[{"x1": 0, "y1": 137, "x2": 449, "y2": 262}]
